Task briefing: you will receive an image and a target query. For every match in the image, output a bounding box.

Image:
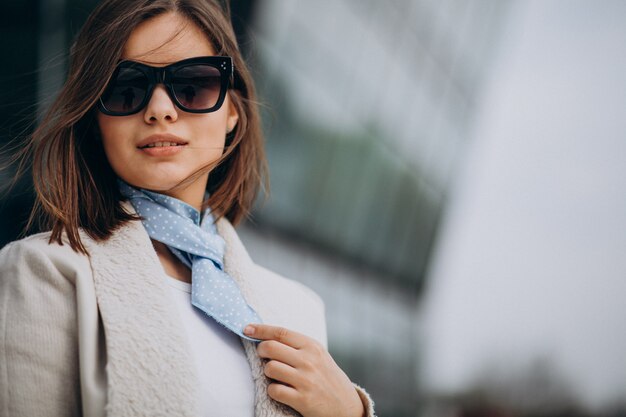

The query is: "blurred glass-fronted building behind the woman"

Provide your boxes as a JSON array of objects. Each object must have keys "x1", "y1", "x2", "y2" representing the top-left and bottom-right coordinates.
[{"x1": 0, "y1": 0, "x2": 509, "y2": 417}]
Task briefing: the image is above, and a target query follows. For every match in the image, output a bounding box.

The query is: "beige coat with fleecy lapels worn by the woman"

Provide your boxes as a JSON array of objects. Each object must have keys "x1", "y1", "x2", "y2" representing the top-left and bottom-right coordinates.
[{"x1": 0, "y1": 208, "x2": 374, "y2": 417}]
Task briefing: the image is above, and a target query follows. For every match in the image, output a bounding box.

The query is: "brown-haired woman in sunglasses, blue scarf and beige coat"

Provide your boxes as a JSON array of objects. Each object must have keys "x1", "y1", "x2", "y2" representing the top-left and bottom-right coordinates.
[{"x1": 0, "y1": 0, "x2": 374, "y2": 417}]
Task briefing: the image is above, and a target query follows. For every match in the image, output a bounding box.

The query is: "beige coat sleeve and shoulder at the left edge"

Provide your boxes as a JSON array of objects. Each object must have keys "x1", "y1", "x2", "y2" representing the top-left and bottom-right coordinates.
[{"x1": 0, "y1": 239, "x2": 81, "y2": 417}]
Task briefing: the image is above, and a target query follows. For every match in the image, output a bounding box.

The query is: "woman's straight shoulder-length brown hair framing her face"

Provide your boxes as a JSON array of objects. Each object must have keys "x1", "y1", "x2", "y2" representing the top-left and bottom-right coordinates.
[{"x1": 21, "y1": 0, "x2": 267, "y2": 254}]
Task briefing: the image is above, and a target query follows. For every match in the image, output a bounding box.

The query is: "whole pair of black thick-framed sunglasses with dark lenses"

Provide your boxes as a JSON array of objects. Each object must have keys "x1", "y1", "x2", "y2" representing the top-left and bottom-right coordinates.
[{"x1": 98, "y1": 56, "x2": 233, "y2": 116}]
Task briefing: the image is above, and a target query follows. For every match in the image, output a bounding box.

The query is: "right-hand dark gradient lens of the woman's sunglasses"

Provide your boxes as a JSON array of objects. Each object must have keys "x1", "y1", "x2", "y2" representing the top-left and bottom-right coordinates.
[{"x1": 172, "y1": 64, "x2": 222, "y2": 110}]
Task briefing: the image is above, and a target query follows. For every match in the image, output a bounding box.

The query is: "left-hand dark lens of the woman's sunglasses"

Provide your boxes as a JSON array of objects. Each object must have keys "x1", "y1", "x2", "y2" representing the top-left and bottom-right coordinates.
[{"x1": 102, "y1": 68, "x2": 149, "y2": 113}]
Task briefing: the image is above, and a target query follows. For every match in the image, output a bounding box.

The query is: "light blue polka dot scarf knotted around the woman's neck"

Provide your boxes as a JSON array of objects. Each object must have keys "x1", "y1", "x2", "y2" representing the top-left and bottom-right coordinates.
[{"x1": 119, "y1": 181, "x2": 262, "y2": 340}]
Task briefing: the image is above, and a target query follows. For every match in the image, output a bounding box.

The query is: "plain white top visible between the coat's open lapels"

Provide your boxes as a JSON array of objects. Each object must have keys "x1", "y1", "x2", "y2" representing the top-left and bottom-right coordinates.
[{"x1": 165, "y1": 275, "x2": 254, "y2": 417}]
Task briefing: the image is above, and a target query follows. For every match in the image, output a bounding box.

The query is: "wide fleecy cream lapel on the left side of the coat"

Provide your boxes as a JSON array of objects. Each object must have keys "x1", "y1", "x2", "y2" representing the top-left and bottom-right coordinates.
[{"x1": 86, "y1": 221, "x2": 199, "y2": 417}]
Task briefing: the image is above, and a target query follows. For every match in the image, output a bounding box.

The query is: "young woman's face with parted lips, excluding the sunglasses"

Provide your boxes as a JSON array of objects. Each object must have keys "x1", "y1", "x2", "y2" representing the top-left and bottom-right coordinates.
[{"x1": 97, "y1": 13, "x2": 238, "y2": 207}]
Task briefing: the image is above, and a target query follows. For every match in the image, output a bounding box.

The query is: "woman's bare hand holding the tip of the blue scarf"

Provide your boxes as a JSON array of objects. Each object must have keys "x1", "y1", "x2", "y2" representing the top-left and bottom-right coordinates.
[{"x1": 244, "y1": 324, "x2": 365, "y2": 417}]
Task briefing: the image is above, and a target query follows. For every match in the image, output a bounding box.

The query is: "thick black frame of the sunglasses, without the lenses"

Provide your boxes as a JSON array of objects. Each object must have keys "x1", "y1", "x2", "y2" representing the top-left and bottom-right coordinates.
[{"x1": 98, "y1": 56, "x2": 234, "y2": 116}]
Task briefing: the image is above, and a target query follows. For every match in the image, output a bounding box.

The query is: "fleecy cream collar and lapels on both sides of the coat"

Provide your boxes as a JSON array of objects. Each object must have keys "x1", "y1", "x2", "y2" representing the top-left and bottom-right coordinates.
[{"x1": 84, "y1": 203, "x2": 299, "y2": 417}]
